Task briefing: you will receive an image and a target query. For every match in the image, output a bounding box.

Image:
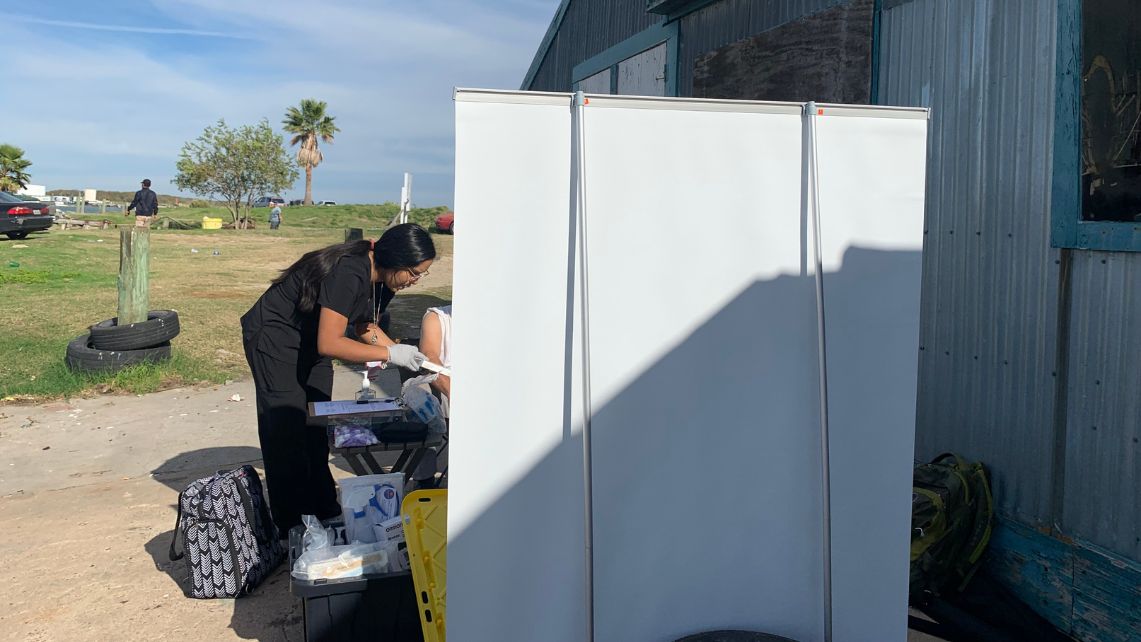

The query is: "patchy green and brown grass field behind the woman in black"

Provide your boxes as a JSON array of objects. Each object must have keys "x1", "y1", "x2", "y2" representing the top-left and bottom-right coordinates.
[{"x1": 0, "y1": 215, "x2": 452, "y2": 401}]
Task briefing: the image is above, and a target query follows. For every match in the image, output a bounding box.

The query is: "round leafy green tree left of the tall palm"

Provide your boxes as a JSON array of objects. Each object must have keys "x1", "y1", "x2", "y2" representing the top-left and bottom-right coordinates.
[{"x1": 172, "y1": 119, "x2": 300, "y2": 229}]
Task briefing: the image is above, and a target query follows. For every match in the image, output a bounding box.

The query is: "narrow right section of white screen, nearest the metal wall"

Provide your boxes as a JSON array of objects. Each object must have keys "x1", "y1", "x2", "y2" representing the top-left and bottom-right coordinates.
[{"x1": 816, "y1": 105, "x2": 928, "y2": 642}]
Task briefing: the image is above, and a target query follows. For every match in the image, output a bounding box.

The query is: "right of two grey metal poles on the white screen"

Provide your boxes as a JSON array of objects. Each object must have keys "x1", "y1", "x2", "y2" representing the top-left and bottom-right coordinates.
[{"x1": 804, "y1": 103, "x2": 832, "y2": 642}]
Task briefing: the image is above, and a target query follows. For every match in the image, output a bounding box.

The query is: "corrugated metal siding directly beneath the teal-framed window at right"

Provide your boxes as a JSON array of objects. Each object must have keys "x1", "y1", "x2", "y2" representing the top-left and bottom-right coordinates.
[{"x1": 1062, "y1": 251, "x2": 1141, "y2": 560}]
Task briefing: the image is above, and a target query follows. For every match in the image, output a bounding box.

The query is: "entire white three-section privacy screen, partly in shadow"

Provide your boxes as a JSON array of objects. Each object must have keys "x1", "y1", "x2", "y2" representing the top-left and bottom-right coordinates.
[{"x1": 447, "y1": 91, "x2": 925, "y2": 642}]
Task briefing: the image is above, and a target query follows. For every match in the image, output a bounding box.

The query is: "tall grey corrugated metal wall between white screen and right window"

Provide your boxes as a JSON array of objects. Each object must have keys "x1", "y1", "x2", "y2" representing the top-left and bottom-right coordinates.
[{"x1": 877, "y1": 0, "x2": 1059, "y2": 526}]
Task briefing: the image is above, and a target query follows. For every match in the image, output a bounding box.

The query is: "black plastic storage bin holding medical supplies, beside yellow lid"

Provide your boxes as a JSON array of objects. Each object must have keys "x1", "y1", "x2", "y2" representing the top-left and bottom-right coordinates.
[{"x1": 289, "y1": 526, "x2": 423, "y2": 642}]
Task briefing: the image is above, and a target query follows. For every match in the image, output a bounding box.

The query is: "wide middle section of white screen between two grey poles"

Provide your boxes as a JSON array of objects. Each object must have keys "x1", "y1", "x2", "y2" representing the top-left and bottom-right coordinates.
[{"x1": 584, "y1": 98, "x2": 823, "y2": 641}]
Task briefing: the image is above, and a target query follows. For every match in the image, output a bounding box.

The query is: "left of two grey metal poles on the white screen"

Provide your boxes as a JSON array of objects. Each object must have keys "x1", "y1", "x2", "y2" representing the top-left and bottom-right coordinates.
[{"x1": 572, "y1": 91, "x2": 594, "y2": 642}]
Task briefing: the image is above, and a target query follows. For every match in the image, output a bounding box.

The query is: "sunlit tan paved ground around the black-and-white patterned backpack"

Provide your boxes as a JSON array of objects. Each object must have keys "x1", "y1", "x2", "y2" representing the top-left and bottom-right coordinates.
[{"x1": 0, "y1": 367, "x2": 385, "y2": 642}]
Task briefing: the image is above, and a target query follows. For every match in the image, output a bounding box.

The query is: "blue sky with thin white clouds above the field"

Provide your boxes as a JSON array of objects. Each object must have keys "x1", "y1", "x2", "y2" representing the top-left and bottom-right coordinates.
[{"x1": 0, "y1": 0, "x2": 558, "y2": 206}]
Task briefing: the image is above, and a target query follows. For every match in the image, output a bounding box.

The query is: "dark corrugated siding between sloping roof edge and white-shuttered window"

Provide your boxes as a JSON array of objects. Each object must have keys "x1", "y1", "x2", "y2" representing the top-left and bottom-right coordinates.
[{"x1": 525, "y1": 0, "x2": 665, "y2": 91}]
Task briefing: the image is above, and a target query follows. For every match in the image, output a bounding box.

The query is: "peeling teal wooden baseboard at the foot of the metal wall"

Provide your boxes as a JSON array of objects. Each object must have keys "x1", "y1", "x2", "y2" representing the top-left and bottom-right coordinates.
[{"x1": 984, "y1": 519, "x2": 1141, "y2": 642}]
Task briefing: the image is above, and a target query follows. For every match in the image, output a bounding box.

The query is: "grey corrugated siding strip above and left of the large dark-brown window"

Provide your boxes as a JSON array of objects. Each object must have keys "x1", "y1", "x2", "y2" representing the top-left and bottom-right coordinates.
[{"x1": 678, "y1": 0, "x2": 848, "y2": 96}]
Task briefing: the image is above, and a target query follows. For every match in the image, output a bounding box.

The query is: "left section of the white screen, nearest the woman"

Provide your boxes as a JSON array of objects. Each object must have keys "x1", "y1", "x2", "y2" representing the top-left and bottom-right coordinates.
[{"x1": 447, "y1": 94, "x2": 586, "y2": 642}]
